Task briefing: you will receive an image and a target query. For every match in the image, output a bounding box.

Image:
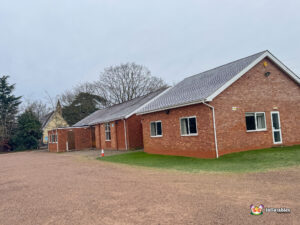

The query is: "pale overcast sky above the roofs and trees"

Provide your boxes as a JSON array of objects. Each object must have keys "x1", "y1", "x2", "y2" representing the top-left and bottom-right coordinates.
[{"x1": 0, "y1": 0, "x2": 300, "y2": 102}]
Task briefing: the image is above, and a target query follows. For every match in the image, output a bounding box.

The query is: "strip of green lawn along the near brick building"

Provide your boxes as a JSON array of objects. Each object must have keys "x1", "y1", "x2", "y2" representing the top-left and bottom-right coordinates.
[{"x1": 98, "y1": 145, "x2": 300, "y2": 173}]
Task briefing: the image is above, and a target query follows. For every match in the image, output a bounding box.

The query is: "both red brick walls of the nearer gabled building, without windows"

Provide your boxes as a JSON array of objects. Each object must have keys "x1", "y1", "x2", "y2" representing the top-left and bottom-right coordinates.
[{"x1": 142, "y1": 59, "x2": 300, "y2": 157}]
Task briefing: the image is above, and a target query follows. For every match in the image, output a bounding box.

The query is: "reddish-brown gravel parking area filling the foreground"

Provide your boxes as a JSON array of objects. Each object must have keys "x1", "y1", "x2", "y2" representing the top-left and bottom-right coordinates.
[{"x1": 0, "y1": 151, "x2": 300, "y2": 225}]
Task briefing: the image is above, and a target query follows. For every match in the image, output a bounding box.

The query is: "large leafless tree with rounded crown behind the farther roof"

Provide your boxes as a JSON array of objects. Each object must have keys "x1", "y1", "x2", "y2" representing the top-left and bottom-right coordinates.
[{"x1": 94, "y1": 63, "x2": 167, "y2": 104}]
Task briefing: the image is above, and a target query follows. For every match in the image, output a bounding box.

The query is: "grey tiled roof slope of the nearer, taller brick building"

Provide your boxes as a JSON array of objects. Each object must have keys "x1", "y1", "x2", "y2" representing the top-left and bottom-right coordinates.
[{"x1": 138, "y1": 51, "x2": 266, "y2": 113}]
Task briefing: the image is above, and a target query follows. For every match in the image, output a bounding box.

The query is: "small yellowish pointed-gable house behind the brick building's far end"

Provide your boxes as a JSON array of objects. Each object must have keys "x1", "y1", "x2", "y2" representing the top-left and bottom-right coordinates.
[{"x1": 42, "y1": 100, "x2": 69, "y2": 144}]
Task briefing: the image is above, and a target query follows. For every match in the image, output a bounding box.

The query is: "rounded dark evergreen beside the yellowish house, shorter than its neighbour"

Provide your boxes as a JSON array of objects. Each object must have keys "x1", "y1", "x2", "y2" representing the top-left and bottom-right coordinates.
[{"x1": 12, "y1": 110, "x2": 42, "y2": 150}]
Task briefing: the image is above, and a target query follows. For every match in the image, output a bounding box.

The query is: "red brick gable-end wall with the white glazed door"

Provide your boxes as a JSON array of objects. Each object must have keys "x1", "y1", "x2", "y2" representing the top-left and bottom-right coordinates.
[{"x1": 211, "y1": 59, "x2": 300, "y2": 155}]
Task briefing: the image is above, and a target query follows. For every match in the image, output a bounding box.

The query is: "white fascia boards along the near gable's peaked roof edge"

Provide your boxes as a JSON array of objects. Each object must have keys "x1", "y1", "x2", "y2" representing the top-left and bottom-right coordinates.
[{"x1": 206, "y1": 51, "x2": 300, "y2": 102}]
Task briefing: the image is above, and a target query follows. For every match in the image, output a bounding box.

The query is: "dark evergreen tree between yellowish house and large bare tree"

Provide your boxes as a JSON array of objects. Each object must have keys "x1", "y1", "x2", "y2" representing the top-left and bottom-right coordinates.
[{"x1": 62, "y1": 92, "x2": 106, "y2": 125}]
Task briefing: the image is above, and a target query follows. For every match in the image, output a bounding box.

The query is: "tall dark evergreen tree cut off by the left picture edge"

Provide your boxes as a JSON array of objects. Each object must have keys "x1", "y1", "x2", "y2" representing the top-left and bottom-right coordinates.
[{"x1": 0, "y1": 76, "x2": 21, "y2": 150}]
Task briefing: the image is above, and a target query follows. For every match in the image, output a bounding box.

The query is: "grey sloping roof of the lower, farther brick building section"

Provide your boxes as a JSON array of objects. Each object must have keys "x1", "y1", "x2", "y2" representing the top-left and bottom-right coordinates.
[{"x1": 73, "y1": 88, "x2": 165, "y2": 127}]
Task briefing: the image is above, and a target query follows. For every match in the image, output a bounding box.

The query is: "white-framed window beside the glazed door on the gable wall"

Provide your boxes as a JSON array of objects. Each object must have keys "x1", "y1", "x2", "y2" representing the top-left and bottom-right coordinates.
[{"x1": 246, "y1": 112, "x2": 266, "y2": 131}]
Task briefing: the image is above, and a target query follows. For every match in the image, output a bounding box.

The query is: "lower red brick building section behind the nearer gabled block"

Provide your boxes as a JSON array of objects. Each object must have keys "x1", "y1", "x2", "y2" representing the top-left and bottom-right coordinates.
[{"x1": 48, "y1": 89, "x2": 165, "y2": 152}]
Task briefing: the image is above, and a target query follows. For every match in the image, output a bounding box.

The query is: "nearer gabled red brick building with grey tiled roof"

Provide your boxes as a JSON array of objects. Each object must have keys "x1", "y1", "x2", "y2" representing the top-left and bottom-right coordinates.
[{"x1": 137, "y1": 51, "x2": 300, "y2": 158}]
